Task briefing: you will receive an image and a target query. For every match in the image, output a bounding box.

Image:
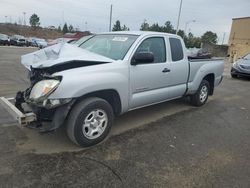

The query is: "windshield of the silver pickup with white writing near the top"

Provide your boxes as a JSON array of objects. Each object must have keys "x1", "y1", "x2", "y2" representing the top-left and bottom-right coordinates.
[{"x1": 79, "y1": 34, "x2": 138, "y2": 60}]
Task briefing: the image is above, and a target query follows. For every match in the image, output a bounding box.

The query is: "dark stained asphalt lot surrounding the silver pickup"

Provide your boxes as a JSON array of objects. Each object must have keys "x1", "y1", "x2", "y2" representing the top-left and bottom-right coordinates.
[{"x1": 0, "y1": 47, "x2": 250, "y2": 188}]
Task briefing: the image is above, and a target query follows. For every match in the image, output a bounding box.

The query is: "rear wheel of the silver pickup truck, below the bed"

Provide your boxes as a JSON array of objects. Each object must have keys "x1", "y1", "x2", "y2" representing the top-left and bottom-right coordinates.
[{"x1": 191, "y1": 80, "x2": 210, "y2": 106}]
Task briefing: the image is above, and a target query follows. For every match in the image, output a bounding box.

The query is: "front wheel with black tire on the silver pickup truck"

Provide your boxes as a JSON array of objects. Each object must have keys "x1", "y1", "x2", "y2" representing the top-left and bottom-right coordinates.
[{"x1": 66, "y1": 97, "x2": 114, "y2": 147}]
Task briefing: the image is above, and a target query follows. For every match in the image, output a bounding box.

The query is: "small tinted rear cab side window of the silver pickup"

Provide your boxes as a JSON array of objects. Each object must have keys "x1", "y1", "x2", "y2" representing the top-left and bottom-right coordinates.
[{"x1": 169, "y1": 38, "x2": 183, "y2": 61}]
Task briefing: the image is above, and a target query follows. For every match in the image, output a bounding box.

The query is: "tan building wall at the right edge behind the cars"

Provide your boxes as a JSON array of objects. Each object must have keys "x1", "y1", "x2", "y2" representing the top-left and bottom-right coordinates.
[{"x1": 228, "y1": 17, "x2": 250, "y2": 62}]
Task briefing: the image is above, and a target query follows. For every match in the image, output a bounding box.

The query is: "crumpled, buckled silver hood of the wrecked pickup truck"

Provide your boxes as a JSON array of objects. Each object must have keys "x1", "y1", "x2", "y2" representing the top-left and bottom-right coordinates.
[{"x1": 21, "y1": 43, "x2": 114, "y2": 70}]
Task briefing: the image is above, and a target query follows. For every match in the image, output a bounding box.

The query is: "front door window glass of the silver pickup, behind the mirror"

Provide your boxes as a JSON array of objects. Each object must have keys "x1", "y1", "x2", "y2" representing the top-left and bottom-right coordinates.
[{"x1": 136, "y1": 37, "x2": 166, "y2": 63}]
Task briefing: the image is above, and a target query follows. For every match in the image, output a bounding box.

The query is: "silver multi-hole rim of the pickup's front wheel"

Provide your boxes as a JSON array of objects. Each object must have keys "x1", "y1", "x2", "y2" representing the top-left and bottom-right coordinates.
[{"x1": 82, "y1": 109, "x2": 108, "y2": 139}]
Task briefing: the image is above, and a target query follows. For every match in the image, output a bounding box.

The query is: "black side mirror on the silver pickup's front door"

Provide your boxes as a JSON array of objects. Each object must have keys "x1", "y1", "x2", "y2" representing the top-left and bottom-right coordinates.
[{"x1": 131, "y1": 52, "x2": 154, "y2": 65}]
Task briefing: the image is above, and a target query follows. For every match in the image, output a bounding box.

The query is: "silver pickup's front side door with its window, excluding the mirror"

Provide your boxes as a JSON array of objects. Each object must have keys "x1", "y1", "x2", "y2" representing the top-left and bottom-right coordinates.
[{"x1": 129, "y1": 36, "x2": 170, "y2": 109}]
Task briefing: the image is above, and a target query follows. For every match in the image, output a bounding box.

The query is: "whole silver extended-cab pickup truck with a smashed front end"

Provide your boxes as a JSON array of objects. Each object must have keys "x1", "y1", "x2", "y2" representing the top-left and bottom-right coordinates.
[{"x1": 1, "y1": 32, "x2": 224, "y2": 147}]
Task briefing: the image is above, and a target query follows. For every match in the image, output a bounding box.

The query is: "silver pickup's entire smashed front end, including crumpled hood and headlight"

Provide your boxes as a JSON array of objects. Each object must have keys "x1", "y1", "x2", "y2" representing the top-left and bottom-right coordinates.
[{"x1": 4, "y1": 43, "x2": 113, "y2": 131}]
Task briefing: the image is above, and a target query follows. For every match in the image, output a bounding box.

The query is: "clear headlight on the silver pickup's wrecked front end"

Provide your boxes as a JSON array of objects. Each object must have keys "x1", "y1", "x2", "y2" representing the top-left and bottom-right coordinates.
[{"x1": 30, "y1": 80, "x2": 60, "y2": 100}]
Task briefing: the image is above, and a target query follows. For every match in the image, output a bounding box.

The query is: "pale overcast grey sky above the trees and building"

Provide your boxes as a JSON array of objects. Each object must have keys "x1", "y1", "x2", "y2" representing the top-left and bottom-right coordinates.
[{"x1": 0, "y1": 0, "x2": 250, "y2": 43}]
